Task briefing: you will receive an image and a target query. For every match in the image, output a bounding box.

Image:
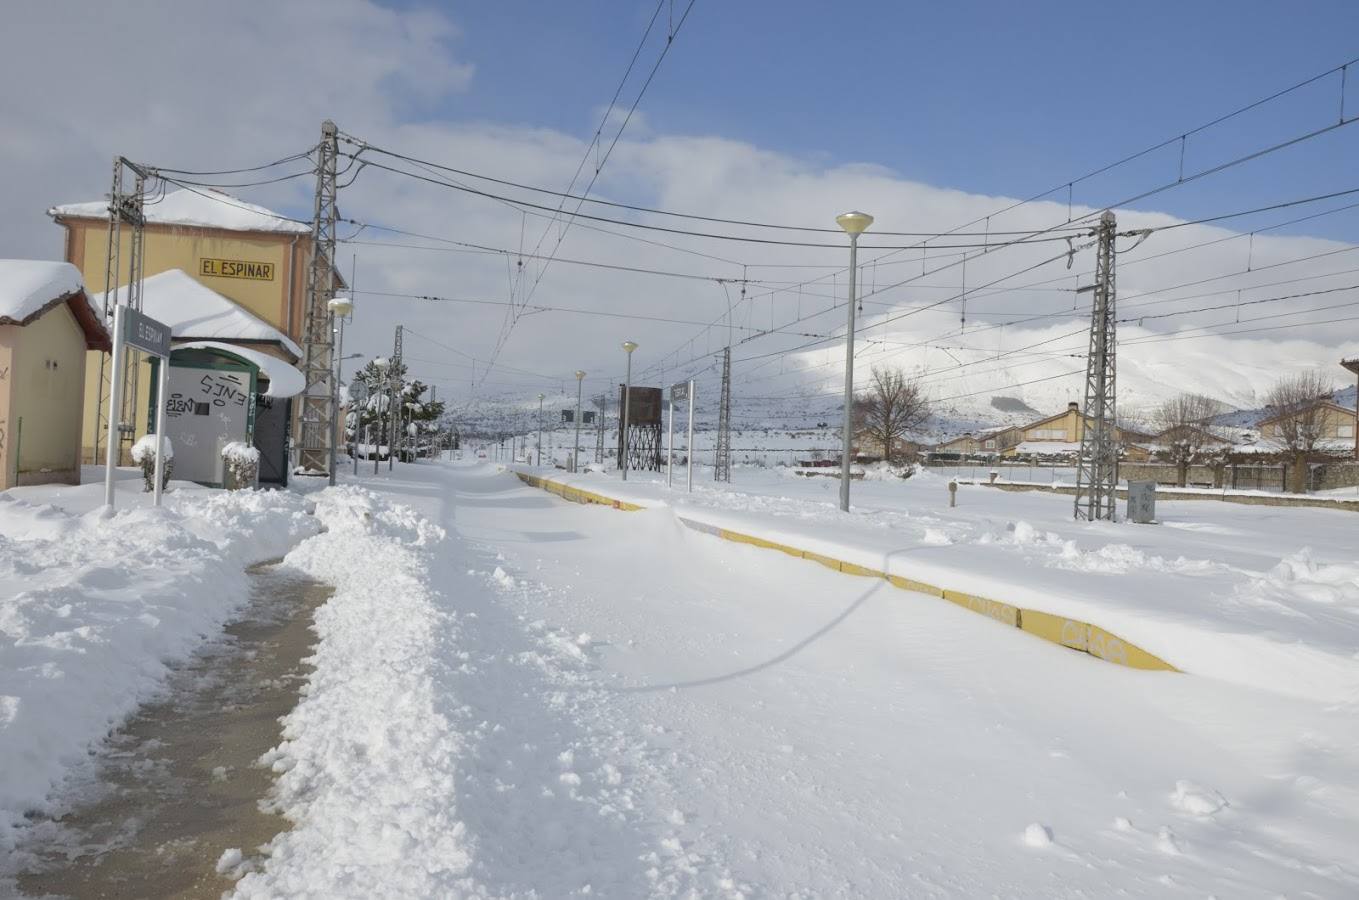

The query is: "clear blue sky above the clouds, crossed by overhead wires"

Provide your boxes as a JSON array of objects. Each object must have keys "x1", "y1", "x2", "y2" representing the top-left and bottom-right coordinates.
[{"x1": 394, "y1": 0, "x2": 1359, "y2": 237}]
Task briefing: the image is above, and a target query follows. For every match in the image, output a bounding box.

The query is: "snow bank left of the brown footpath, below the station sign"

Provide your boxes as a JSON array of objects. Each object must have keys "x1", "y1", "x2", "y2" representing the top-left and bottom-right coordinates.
[{"x1": 0, "y1": 485, "x2": 317, "y2": 851}]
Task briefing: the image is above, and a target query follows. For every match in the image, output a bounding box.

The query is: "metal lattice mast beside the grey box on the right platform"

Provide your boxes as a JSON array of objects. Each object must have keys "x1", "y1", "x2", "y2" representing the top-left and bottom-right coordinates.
[{"x1": 1075, "y1": 209, "x2": 1118, "y2": 522}]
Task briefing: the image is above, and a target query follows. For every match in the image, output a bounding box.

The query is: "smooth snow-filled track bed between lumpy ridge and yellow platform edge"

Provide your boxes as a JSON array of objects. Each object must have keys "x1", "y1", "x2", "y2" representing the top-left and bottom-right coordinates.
[{"x1": 345, "y1": 464, "x2": 1359, "y2": 897}]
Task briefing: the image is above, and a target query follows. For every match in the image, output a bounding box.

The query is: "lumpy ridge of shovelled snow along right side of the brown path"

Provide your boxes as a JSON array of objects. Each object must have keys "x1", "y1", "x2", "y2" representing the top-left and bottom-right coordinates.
[{"x1": 236, "y1": 487, "x2": 478, "y2": 897}]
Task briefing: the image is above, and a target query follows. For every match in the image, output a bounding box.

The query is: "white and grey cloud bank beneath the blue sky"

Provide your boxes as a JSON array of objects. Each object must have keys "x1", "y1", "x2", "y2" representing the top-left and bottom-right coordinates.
[{"x1": 0, "y1": 0, "x2": 1359, "y2": 421}]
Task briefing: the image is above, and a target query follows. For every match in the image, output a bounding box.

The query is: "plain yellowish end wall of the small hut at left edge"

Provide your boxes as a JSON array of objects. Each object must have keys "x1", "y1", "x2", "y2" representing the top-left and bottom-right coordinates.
[{"x1": 0, "y1": 303, "x2": 86, "y2": 487}]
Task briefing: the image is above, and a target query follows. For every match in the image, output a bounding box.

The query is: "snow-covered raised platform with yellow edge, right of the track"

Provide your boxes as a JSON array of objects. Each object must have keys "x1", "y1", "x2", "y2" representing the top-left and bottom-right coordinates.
[{"x1": 514, "y1": 466, "x2": 1359, "y2": 702}]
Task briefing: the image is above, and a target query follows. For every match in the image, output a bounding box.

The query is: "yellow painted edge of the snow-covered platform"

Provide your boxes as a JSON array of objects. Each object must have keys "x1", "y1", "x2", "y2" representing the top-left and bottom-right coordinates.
[{"x1": 515, "y1": 472, "x2": 1180, "y2": 672}]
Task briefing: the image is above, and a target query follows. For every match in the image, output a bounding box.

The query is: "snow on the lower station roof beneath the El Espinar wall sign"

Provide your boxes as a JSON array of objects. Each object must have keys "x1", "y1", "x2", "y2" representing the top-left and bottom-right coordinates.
[{"x1": 91, "y1": 269, "x2": 302, "y2": 359}]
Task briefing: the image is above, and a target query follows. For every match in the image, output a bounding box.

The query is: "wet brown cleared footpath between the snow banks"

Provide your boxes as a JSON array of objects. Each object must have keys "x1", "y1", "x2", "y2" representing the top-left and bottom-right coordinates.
[{"x1": 18, "y1": 566, "x2": 330, "y2": 899}]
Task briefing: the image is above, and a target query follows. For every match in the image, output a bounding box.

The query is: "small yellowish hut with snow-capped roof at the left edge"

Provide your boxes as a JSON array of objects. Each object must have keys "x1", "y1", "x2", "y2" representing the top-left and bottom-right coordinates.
[{"x1": 0, "y1": 260, "x2": 110, "y2": 488}]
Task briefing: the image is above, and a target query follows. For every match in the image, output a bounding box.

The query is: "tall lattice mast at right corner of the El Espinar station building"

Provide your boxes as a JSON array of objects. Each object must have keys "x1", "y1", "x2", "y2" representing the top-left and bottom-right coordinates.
[{"x1": 298, "y1": 118, "x2": 338, "y2": 474}]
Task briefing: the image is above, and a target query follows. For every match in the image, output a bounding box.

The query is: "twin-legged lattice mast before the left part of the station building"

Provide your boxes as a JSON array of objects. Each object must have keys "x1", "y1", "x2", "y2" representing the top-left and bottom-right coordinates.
[{"x1": 91, "y1": 156, "x2": 151, "y2": 464}]
